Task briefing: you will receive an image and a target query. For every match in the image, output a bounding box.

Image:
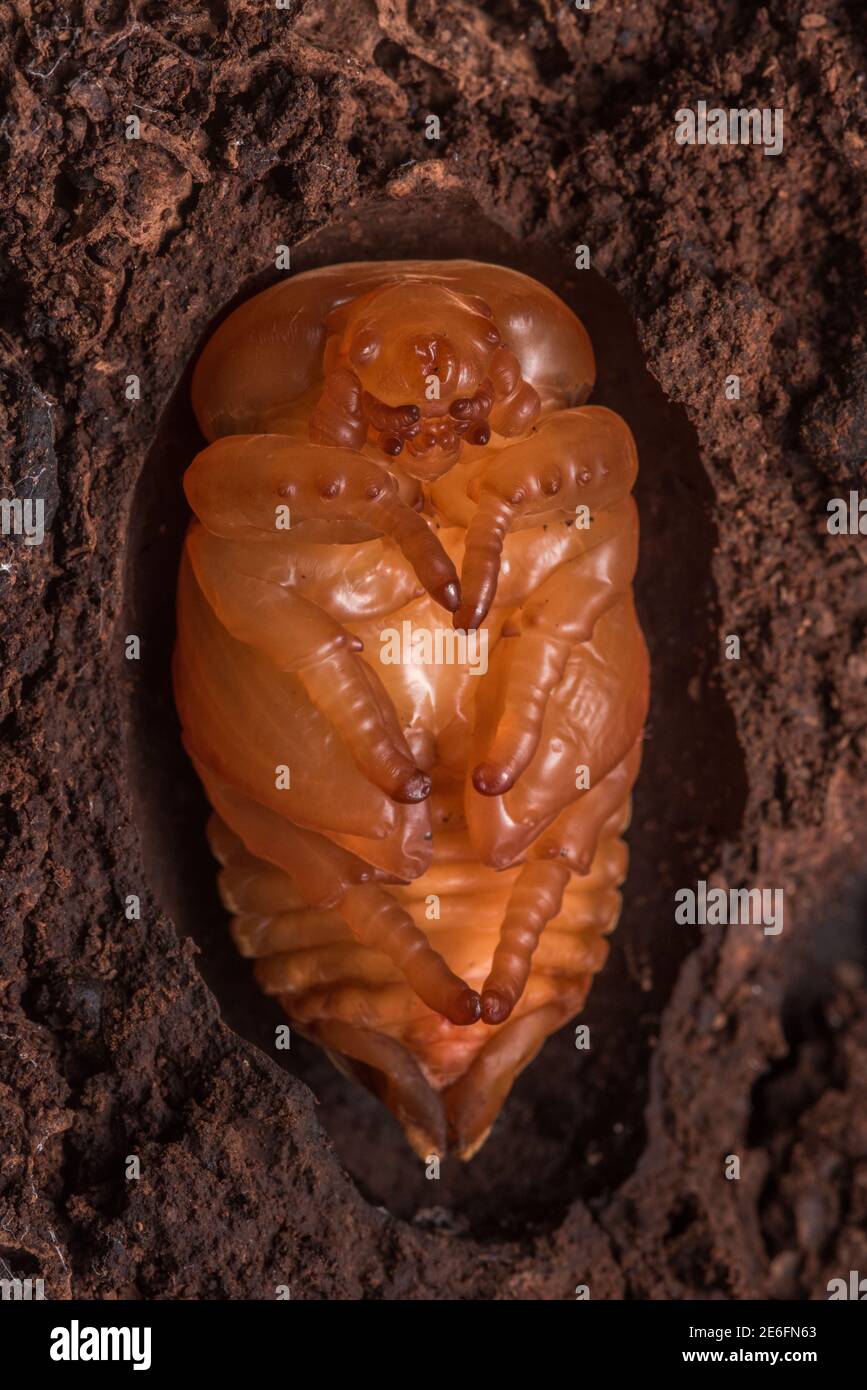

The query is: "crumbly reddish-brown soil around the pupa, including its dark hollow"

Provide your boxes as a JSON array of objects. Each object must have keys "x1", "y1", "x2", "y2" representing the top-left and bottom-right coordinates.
[{"x1": 0, "y1": 0, "x2": 867, "y2": 1300}]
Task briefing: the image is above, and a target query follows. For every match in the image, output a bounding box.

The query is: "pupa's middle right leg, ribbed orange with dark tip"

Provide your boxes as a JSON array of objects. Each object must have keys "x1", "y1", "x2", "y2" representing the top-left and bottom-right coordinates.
[{"x1": 472, "y1": 498, "x2": 638, "y2": 796}]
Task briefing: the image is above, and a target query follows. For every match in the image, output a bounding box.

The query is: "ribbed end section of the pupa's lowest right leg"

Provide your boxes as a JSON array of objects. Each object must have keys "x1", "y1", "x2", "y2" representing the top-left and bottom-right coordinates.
[{"x1": 482, "y1": 860, "x2": 570, "y2": 1023}]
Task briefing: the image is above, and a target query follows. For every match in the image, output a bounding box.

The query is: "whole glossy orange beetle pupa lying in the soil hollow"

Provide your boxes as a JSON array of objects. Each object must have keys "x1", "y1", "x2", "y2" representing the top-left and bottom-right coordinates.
[{"x1": 174, "y1": 261, "x2": 647, "y2": 1158}]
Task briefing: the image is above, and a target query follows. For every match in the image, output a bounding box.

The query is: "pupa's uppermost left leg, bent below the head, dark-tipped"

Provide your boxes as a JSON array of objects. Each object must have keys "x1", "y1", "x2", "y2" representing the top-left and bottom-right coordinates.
[{"x1": 183, "y1": 435, "x2": 460, "y2": 613}]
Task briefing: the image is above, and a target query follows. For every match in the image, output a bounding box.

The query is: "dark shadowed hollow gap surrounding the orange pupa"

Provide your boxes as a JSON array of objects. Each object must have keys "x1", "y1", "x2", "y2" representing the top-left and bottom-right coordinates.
[{"x1": 125, "y1": 193, "x2": 746, "y2": 1240}]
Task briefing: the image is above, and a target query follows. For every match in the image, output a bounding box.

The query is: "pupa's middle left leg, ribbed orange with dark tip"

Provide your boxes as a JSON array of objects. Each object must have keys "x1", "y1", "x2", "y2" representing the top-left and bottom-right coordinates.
[{"x1": 186, "y1": 525, "x2": 431, "y2": 803}]
